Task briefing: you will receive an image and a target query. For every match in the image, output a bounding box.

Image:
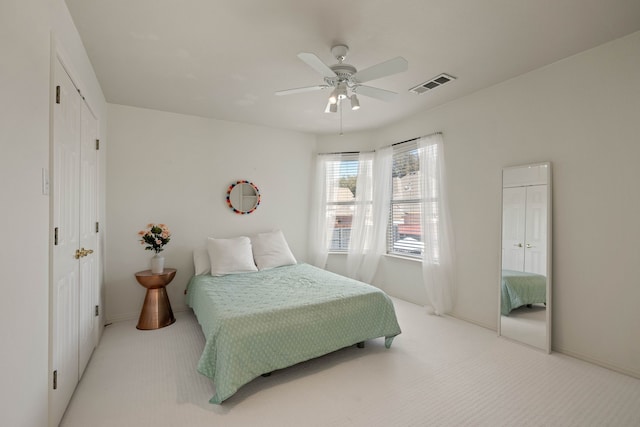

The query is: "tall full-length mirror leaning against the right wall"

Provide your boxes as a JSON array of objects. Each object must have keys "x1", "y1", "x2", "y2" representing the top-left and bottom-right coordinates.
[{"x1": 499, "y1": 162, "x2": 551, "y2": 352}]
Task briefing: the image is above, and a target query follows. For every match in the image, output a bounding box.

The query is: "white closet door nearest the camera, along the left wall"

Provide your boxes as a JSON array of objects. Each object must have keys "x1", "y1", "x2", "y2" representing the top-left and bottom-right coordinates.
[{"x1": 50, "y1": 61, "x2": 82, "y2": 425}]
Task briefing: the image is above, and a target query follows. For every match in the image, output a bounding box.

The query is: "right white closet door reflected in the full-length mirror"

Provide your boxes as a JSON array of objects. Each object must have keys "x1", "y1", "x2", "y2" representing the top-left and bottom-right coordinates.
[{"x1": 524, "y1": 185, "x2": 547, "y2": 275}]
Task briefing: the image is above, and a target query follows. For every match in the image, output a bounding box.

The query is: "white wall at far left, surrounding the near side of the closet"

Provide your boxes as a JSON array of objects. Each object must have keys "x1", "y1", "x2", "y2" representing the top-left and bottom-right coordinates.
[{"x1": 0, "y1": 0, "x2": 106, "y2": 427}]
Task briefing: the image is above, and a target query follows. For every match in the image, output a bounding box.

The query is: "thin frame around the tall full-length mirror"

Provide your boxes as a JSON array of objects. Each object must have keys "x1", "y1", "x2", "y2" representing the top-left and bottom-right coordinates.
[{"x1": 498, "y1": 162, "x2": 553, "y2": 353}]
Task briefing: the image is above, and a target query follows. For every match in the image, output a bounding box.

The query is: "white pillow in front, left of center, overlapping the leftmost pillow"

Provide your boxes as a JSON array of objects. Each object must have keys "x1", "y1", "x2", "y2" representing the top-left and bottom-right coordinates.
[{"x1": 207, "y1": 236, "x2": 258, "y2": 276}]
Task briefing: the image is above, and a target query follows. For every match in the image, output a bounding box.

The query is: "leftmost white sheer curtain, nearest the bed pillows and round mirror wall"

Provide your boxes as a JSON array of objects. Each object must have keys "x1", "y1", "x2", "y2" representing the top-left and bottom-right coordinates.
[{"x1": 309, "y1": 154, "x2": 340, "y2": 268}]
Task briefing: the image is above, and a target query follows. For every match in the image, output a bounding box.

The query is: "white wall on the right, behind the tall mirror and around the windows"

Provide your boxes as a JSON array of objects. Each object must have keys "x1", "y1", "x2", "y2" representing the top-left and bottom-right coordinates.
[{"x1": 318, "y1": 33, "x2": 640, "y2": 377}]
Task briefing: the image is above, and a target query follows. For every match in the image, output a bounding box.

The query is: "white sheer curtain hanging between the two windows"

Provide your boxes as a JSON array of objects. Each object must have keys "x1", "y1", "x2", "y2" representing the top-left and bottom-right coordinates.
[{"x1": 347, "y1": 147, "x2": 393, "y2": 283}]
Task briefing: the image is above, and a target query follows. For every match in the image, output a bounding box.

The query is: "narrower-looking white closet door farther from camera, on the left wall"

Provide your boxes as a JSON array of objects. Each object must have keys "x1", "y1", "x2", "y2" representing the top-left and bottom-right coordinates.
[{"x1": 78, "y1": 102, "x2": 98, "y2": 376}]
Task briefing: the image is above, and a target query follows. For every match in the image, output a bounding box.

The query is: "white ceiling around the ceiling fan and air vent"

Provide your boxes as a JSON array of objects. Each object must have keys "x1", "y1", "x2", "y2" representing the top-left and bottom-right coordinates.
[{"x1": 66, "y1": 0, "x2": 640, "y2": 134}]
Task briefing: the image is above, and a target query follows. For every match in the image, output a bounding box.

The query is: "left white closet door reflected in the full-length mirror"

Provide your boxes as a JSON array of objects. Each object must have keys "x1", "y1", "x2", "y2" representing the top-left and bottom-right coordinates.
[{"x1": 502, "y1": 187, "x2": 526, "y2": 271}]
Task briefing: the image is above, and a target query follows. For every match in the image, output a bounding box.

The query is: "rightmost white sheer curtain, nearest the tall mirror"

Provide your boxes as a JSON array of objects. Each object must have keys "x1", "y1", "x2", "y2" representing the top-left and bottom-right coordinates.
[{"x1": 418, "y1": 134, "x2": 455, "y2": 315}]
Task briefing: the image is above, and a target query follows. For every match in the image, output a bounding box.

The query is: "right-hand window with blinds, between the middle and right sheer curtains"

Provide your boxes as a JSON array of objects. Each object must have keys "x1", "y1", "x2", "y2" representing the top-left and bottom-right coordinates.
[{"x1": 387, "y1": 141, "x2": 424, "y2": 258}]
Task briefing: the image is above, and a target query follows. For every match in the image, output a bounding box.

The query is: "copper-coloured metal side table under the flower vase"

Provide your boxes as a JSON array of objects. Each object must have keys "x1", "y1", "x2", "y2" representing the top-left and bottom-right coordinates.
[{"x1": 136, "y1": 268, "x2": 176, "y2": 330}]
